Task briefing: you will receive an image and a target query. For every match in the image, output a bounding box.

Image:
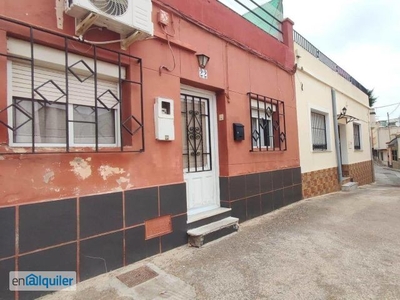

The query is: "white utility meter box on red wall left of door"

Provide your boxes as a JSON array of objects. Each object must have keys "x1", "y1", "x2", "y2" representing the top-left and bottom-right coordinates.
[{"x1": 154, "y1": 97, "x2": 175, "y2": 141}]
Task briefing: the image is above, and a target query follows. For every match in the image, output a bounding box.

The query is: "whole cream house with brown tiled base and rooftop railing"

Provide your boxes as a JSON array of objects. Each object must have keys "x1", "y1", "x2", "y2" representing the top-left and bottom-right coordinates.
[{"x1": 294, "y1": 32, "x2": 373, "y2": 198}]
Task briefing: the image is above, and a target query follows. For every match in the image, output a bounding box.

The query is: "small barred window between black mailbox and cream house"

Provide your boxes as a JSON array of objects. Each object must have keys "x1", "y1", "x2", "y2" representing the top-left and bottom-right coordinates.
[{"x1": 248, "y1": 93, "x2": 287, "y2": 151}]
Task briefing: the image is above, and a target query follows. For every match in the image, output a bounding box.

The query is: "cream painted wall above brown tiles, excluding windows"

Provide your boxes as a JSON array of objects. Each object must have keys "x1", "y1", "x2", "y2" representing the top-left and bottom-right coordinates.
[{"x1": 294, "y1": 43, "x2": 371, "y2": 173}]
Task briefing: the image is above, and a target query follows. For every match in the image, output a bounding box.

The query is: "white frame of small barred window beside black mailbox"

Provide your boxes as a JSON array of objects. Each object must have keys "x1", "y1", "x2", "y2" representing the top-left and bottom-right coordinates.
[{"x1": 250, "y1": 99, "x2": 276, "y2": 149}]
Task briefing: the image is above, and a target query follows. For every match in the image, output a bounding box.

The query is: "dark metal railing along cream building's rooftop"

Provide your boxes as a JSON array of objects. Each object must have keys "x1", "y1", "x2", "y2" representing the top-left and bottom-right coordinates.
[{"x1": 293, "y1": 31, "x2": 368, "y2": 94}]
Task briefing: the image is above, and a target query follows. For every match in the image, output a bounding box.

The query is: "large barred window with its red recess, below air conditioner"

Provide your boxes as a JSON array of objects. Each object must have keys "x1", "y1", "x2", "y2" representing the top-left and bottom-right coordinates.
[{"x1": 0, "y1": 17, "x2": 144, "y2": 154}]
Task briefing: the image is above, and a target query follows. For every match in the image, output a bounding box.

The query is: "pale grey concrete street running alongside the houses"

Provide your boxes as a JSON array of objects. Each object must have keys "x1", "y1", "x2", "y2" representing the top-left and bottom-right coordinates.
[{"x1": 43, "y1": 166, "x2": 400, "y2": 300}]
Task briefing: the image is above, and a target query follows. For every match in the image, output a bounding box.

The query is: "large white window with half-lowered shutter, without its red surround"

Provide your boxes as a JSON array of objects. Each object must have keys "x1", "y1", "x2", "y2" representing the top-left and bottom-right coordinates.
[{"x1": 9, "y1": 62, "x2": 120, "y2": 147}]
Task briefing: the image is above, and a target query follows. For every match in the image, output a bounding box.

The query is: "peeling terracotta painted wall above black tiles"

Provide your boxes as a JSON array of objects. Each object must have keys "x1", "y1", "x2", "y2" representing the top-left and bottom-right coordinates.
[{"x1": 0, "y1": 0, "x2": 299, "y2": 206}]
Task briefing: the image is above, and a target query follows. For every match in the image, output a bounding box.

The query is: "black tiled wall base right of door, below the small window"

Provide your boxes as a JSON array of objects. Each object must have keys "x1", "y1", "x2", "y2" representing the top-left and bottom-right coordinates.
[{"x1": 220, "y1": 168, "x2": 302, "y2": 222}]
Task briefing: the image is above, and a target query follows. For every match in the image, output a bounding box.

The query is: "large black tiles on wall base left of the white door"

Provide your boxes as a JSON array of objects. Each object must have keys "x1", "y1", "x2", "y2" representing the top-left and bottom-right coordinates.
[{"x1": 0, "y1": 183, "x2": 187, "y2": 300}]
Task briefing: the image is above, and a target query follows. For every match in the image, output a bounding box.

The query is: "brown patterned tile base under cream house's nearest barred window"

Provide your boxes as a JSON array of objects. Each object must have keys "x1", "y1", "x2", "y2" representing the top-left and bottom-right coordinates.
[{"x1": 302, "y1": 168, "x2": 340, "y2": 198}]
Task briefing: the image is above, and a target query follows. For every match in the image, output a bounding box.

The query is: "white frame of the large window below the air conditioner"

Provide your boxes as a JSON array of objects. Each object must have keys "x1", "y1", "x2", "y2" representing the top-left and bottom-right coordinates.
[{"x1": 7, "y1": 59, "x2": 121, "y2": 148}]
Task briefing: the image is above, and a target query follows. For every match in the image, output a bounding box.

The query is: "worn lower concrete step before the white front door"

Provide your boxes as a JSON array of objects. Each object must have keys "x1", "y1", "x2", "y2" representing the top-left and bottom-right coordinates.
[{"x1": 187, "y1": 217, "x2": 239, "y2": 247}]
